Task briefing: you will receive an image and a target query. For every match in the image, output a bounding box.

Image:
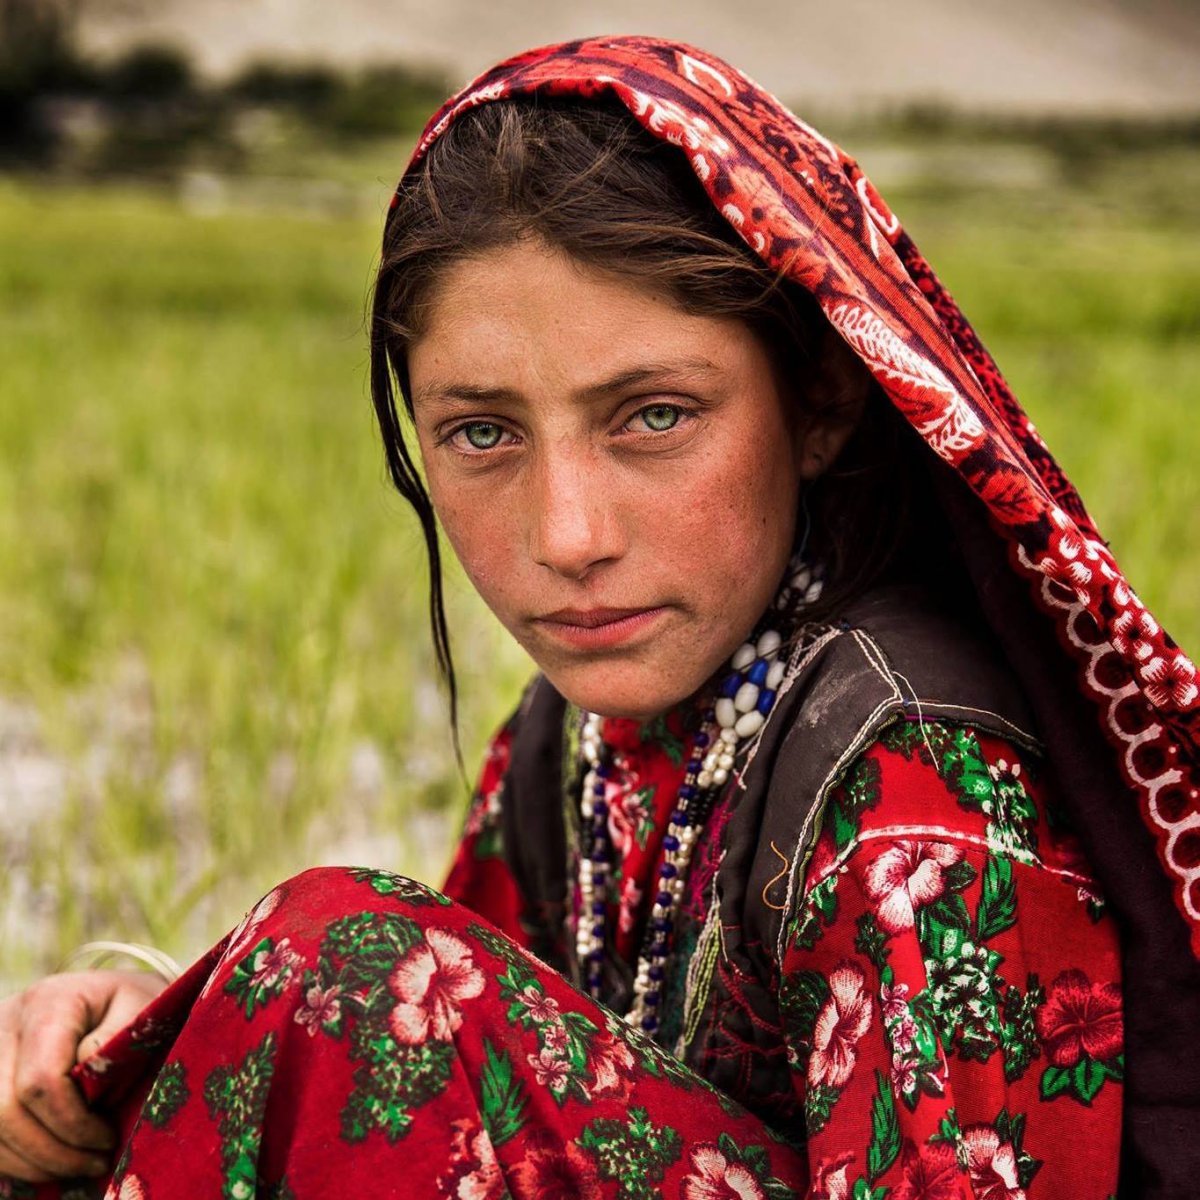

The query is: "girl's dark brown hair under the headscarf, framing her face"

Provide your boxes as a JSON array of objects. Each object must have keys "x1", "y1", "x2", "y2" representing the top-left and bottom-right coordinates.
[{"x1": 371, "y1": 98, "x2": 950, "y2": 714}]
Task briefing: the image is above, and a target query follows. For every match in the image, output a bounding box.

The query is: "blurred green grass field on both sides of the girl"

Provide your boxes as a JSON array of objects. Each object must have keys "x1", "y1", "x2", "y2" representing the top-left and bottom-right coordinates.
[{"x1": 0, "y1": 136, "x2": 1200, "y2": 990}]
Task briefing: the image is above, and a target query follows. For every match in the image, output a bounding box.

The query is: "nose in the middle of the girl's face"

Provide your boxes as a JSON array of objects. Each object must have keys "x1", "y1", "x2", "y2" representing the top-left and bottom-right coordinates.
[{"x1": 528, "y1": 448, "x2": 625, "y2": 580}]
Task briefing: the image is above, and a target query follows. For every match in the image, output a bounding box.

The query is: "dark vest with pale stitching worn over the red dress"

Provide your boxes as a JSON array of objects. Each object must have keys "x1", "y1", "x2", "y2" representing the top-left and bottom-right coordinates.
[{"x1": 504, "y1": 586, "x2": 1037, "y2": 1133}]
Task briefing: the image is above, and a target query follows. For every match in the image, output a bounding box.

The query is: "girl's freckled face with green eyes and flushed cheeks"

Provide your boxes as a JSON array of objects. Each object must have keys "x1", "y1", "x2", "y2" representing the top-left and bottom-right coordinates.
[{"x1": 408, "y1": 240, "x2": 820, "y2": 719}]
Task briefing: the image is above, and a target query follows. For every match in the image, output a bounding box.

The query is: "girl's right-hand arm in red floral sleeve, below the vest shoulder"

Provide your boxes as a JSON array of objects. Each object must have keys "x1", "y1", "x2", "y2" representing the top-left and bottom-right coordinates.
[{"x1": 780, "y1": 726, "x2": 1123, "y2": 1200}]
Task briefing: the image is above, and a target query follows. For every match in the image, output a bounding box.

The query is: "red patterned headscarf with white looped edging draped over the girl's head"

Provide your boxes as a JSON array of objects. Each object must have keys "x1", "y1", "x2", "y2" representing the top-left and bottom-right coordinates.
[{"x1": 393, "y1": 37, "x2": 1200, "y2": 961}]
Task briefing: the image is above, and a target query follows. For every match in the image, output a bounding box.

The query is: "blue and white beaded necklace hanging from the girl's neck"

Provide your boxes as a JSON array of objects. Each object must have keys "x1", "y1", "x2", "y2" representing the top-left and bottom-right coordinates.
[{"x1": 575, "y1": 560, "x2": 822, "y2": 1036}]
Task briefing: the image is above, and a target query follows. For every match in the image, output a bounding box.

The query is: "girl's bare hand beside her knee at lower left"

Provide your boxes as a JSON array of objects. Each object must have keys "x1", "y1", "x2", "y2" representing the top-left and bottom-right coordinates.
[{"x1": 0, "y1": 971, "x2": 166, "y2": 1183}]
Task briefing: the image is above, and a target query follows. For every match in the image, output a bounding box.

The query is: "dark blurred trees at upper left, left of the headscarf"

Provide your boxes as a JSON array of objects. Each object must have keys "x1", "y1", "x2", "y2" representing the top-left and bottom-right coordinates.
[{"x1": 0, "y1": 0, "x2": 450, "y2": 173}]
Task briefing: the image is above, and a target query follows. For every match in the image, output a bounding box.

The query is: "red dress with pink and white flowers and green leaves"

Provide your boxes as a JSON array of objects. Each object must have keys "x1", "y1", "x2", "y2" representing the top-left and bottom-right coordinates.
[{"x1": 16, "y1": 700, "x2": 1122, "y2": 1200}]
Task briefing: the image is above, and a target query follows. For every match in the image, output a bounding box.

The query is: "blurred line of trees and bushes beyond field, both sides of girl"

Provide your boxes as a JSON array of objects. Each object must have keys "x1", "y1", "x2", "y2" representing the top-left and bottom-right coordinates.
[{"x1": 0, "y1": 0, "x2": 1200, "y2": 175}]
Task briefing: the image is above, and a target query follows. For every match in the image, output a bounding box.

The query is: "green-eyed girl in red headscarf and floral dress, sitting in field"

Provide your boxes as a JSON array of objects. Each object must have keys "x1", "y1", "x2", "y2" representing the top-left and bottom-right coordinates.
[{"x1": 0, "y1": 37, "x2": 1200, "y2": 1200}]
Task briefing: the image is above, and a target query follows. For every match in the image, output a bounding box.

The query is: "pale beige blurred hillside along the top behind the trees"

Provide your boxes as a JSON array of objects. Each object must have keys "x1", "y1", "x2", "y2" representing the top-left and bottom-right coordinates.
[{"x1": 79, "y1": 0, "x2": 1200, "y2": 115}]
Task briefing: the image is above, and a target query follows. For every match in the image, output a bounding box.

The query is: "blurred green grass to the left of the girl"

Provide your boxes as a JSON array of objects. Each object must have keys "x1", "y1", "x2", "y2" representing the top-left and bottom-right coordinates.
[{"x1": 0, "y1": 160, "x2": 537, "y2": 983}]
